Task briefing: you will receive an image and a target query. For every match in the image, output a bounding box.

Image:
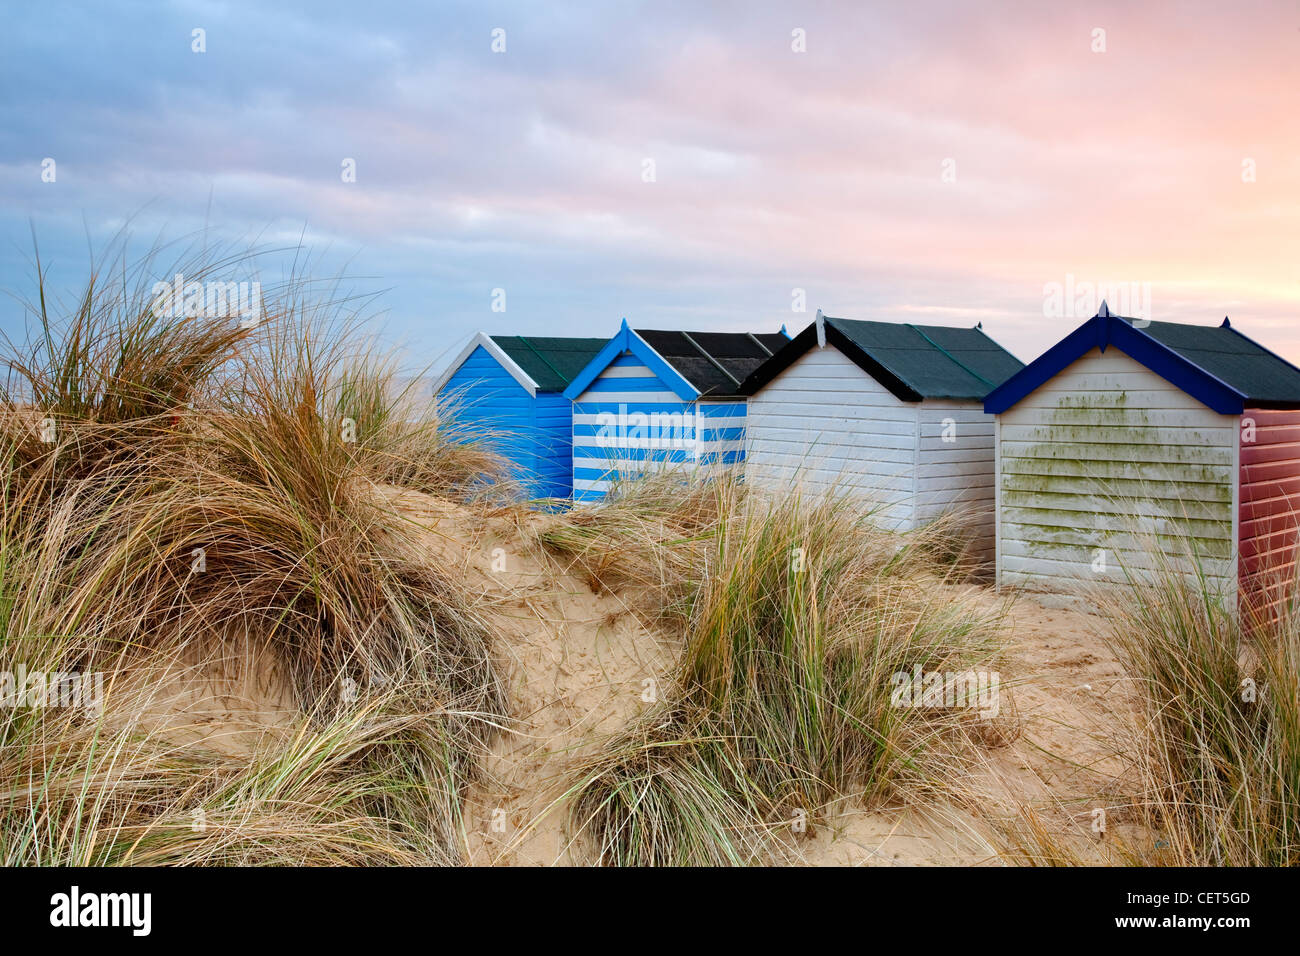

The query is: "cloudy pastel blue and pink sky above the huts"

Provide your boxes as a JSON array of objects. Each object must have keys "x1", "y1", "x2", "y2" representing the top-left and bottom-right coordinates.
[{"x1": 0, "y1": 0, "x2": 1300, "y2": 365}]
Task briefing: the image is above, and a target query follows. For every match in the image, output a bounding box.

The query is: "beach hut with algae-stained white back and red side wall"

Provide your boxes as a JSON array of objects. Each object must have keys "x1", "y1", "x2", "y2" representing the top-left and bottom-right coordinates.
[{"x1": 984, "y1": 303, "x2": 1300, "y2": 609}]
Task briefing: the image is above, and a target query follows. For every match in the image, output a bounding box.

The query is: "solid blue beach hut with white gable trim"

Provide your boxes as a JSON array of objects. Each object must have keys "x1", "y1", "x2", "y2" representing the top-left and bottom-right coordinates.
[{"x1": 433, "y1": 332, "x2": 607, "y2": 498}]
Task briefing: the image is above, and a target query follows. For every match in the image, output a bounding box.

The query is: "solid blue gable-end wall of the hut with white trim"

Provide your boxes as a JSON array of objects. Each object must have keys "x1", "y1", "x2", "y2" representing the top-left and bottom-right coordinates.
[{"x1": 438, "y1": 346, "x2": 547, "y2": 497}]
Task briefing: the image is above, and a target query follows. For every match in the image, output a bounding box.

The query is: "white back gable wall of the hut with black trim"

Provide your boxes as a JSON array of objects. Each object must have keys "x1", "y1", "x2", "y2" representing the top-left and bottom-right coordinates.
[{"x1": 745, "y1": 346, "x2": 918, "y2": 528}]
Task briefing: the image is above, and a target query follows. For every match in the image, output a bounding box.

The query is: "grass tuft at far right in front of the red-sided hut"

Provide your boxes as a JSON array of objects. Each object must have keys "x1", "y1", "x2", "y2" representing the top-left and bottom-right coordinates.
[{"x1": 1102, "y1": 548, "x2": 1300, "y2": 866}]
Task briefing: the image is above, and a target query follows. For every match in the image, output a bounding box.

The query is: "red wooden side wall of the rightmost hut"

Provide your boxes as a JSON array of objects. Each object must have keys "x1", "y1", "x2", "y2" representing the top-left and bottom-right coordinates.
[{"x1": 1239, "y1": 408, "x2": 1300, "y2": 613}]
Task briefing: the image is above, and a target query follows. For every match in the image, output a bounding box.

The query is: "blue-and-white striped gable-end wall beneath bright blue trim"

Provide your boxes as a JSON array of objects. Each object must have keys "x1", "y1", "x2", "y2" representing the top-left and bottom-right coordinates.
[{"x1": 573, "y1": 352, "x2": 697, "y2": 501}]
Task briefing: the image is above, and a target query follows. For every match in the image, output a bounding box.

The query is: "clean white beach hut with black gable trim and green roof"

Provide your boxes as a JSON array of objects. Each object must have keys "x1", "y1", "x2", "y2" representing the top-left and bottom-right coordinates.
[{"x1": 745, "y1": 310, "x2": 1023, "y2": 558}]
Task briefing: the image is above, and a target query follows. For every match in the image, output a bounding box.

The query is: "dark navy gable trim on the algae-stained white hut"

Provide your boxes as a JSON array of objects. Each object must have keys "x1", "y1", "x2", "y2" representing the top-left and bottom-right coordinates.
[{"x1": 984, "y1": 315, "x2": 1245, "y2": 415}]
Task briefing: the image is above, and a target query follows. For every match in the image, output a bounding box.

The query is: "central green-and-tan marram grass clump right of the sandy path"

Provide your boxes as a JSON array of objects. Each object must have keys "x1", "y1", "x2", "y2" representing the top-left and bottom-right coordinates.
[{"x1": 547, "y1": 480, "x2": 998, "y2": 865}]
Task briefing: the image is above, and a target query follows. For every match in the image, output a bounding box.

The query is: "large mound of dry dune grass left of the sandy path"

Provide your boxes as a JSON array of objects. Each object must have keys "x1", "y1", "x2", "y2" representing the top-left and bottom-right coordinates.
[{"x1": 0, "y1": 240, "x2": 507, "y2": 864}]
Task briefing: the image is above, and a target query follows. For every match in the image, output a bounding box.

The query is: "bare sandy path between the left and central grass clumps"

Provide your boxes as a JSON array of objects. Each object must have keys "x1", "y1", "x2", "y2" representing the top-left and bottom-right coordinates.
[{"x1": 379, "y1": 493, "x2": 680, "y2": 865}]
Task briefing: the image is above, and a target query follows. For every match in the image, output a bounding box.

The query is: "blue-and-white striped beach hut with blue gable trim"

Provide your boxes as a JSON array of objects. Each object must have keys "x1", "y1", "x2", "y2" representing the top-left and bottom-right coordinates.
[{"x1": 564, "y1": 319, "x2": 789, "y2": 501}]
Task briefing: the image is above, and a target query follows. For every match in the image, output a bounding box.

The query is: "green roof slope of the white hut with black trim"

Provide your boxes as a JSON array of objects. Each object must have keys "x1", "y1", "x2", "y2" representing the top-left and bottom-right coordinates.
[{"x1": 824, "y1": 316, "x2": 1024, "y2": 401}]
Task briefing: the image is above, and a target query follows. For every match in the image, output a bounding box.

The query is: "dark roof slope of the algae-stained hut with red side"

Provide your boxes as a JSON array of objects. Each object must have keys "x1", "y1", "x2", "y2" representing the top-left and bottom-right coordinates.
[{"x1": 1126, "y1": 319, "x2": 1300, "y2": 405}]
